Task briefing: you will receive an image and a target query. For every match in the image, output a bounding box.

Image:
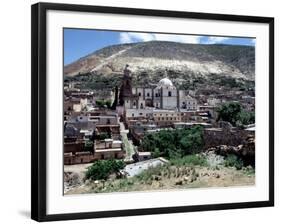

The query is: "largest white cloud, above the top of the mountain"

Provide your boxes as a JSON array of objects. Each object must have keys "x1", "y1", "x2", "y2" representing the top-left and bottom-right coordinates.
[{"x1": 119, "y1": 32, "x2": 201, "y2": 44}]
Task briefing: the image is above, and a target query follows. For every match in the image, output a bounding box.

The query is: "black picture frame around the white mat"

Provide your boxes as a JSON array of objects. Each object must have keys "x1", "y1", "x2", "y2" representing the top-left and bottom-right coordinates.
[{"x1": 31, "y1": 3, "x2": 274, "y2": 221}]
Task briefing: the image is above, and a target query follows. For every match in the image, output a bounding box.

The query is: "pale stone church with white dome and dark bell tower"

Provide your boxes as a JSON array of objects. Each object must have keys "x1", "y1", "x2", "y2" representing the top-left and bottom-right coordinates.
[{"x1": 119, "y1": 65, "x2": 197, "y2": 110}]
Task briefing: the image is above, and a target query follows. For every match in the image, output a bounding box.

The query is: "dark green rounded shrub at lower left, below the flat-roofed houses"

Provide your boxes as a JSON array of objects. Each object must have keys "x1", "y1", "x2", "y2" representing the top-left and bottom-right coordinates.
[{"x1": 86, "y1": 160, "x2": 125, "y2": 180}]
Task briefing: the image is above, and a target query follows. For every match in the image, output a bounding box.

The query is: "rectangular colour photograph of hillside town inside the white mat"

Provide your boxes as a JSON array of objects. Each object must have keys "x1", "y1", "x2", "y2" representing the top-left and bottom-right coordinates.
[{"x1": 63, "y1": 27, "x2": 256, "y2": 196}]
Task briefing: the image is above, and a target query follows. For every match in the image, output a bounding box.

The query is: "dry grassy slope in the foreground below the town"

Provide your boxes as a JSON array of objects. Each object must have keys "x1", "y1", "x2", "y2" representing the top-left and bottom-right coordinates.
[{"x1": 67, "y1": 156, "x2": 255, "y2": 194}]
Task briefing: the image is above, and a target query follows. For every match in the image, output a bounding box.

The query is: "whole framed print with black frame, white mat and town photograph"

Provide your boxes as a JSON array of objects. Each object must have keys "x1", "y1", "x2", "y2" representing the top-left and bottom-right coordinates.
[{"x1": 31, "y1": 3, "x2": 274, "y2": 221}]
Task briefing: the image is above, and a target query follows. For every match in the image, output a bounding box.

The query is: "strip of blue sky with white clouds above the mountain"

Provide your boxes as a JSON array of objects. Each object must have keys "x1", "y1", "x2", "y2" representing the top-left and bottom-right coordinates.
[{"x1": 64, "y1": 29, "x2": 255, "y2": 65}]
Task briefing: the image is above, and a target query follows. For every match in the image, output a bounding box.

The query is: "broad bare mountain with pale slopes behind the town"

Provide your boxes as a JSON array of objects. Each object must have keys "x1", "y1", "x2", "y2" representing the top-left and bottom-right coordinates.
[{"x1": 64, "y1": 41, "x2": 255, "y2": 81}]
